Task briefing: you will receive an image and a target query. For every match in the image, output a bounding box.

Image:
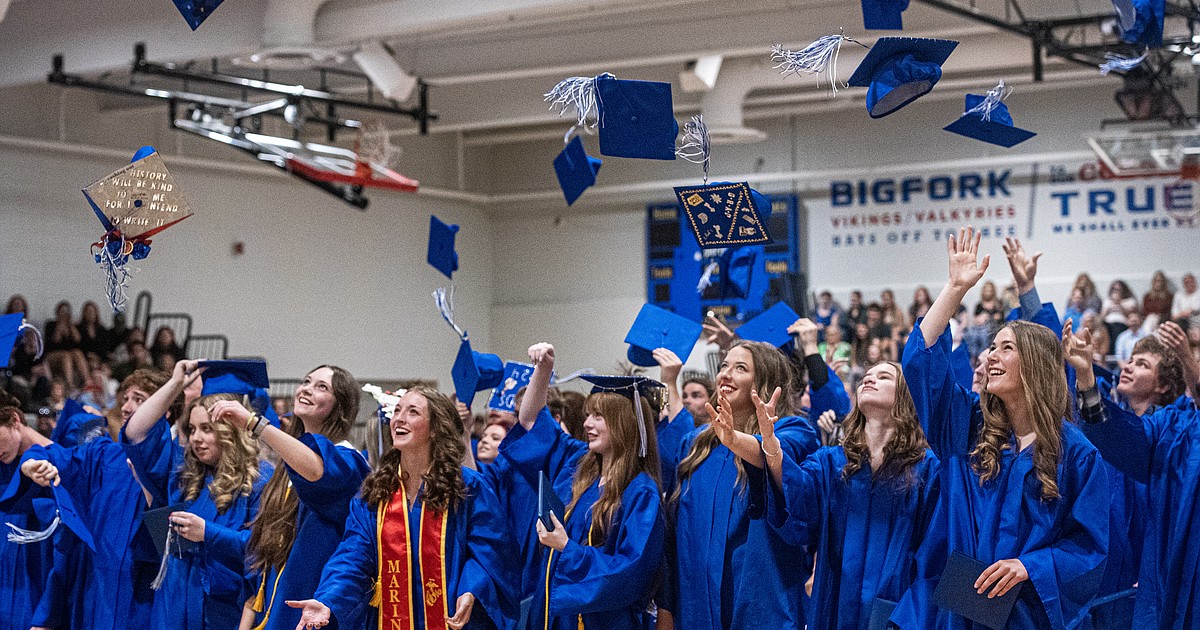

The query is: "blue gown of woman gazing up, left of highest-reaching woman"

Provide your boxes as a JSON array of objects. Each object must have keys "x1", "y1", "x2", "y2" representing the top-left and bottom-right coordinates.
[{"x1": 766, "y1": 446, "x2": 938, "y2": 630}]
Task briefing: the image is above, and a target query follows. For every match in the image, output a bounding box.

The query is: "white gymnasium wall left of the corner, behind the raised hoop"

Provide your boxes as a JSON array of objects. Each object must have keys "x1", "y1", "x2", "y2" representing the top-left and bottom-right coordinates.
[{"x1": 0, "y1": 143, "x2": 492, "y2": 389}]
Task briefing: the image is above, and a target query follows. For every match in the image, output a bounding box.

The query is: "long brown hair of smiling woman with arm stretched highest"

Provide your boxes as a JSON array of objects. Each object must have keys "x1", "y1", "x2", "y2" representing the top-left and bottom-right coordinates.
[{"x1": 971, "y1": 320, "x2": 1070, "y2": 502}]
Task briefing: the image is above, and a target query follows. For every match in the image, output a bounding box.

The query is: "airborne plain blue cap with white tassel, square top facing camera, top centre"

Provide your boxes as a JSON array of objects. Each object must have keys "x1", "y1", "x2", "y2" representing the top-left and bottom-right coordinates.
[{"x1": 545, "y1": 72, "x2": 679, "y2": 160}]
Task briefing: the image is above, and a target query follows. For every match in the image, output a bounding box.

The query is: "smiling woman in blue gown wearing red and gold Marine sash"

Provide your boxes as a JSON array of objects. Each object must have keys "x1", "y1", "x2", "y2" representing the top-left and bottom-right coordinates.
[{"x1": 288, "y1": 388, "x2": 520, "y2": 630}]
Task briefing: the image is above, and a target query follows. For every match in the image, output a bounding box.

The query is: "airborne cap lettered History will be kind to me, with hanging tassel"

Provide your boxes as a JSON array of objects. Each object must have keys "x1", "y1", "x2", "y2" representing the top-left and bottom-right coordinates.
[{"x1": 83, "y1": 146, "x2": 192, "y2": 313}]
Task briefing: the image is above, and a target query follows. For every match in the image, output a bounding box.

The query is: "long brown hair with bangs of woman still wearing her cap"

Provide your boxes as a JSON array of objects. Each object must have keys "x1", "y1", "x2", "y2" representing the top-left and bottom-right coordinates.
[{"x1": 566, "y1": 391, "x2": 661, "y2": 547}]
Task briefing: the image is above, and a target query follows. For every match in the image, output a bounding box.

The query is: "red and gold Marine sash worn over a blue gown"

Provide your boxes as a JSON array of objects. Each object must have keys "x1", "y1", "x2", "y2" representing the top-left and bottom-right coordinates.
[{"x1": 372, "y1": 484, "x2": 450, "y2": 630}]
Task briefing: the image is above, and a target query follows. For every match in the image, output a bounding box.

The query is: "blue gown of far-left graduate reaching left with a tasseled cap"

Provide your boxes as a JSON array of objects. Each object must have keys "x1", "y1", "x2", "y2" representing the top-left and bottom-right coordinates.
[{"x1": 22, "y1": 436, "x2": 158, "y2": 630}]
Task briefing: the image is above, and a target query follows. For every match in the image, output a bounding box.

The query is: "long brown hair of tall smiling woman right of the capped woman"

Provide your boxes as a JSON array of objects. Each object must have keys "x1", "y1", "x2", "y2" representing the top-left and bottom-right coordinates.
[{"x1": 671, "y1": 341, "x2": 796, "y2": 502}]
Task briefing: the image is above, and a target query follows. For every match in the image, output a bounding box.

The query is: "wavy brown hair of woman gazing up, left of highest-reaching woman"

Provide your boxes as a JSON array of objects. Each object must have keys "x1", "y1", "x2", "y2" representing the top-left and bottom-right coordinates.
[{"x1": 841, "y1": 361, "x2": 929, "y2": 487}]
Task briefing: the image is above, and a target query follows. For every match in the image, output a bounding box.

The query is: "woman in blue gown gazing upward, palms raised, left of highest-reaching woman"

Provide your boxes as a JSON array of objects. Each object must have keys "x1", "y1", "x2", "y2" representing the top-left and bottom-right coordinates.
[{"x1": 713, "y1": 362, "x2": 938, "y2": 630}]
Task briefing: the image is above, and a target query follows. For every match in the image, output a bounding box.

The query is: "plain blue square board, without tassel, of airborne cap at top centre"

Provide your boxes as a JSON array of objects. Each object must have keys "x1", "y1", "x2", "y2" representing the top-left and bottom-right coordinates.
[{"x1": 595, "y1": 74, "x2": 679, "y2": 160}]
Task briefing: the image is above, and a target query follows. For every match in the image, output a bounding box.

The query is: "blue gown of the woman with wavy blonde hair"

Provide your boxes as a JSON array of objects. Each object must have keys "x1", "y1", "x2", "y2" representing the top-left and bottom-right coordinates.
[{"x1": 121, "y1": 421, "x2": 274, "y2": 630}]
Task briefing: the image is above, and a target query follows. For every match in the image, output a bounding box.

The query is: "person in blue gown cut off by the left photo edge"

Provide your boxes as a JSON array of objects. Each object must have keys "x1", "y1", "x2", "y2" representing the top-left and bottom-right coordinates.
[{"x1": 0, "y1": 391, "x2": 65, "y2": 630}]
